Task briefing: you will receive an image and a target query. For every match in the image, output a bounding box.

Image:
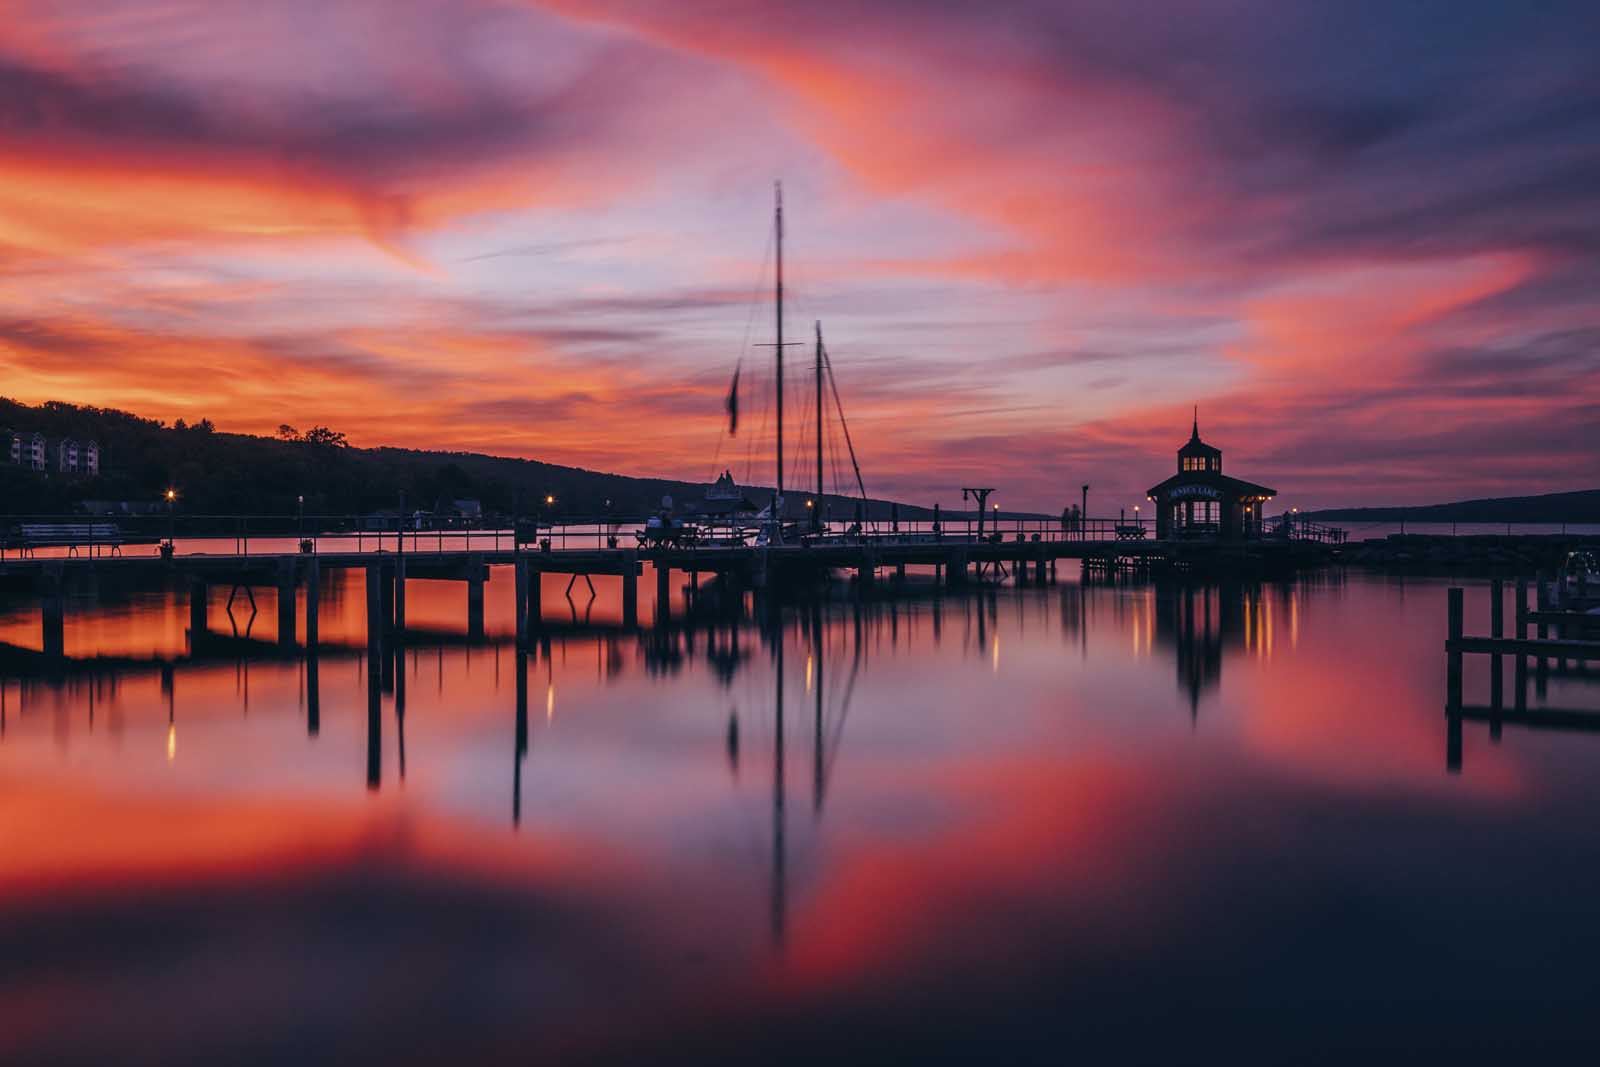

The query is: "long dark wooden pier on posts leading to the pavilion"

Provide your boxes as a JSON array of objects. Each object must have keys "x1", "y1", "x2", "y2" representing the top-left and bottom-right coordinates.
[{"x1": 0, "y1": 523, "x2": 1326, "y2": 657}]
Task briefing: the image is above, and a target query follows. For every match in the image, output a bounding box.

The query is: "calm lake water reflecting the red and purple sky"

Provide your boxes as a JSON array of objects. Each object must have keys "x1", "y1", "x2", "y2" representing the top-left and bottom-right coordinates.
[{"x1": 0, "y1": 565, "x2": 1600, "y2": 1064}]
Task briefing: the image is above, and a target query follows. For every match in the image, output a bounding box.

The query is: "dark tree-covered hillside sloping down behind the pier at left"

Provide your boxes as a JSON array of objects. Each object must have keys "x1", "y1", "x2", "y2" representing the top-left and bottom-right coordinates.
[{"x1": 0, "y1": 397, "x2": 925, "y2": 520}]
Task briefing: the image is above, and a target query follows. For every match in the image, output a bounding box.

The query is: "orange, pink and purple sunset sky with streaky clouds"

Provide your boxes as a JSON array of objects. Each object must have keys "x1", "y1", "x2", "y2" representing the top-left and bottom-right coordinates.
[{"x1": 0, "y1": 0, "x2": 1600, "y2": 510}]
